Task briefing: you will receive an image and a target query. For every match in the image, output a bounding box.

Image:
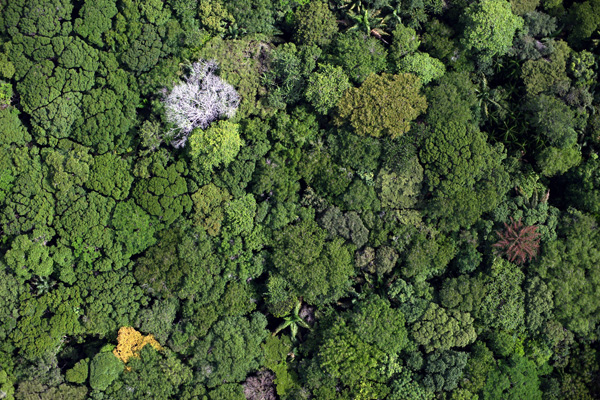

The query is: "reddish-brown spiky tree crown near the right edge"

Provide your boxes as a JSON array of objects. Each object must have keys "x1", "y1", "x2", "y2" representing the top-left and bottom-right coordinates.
[{"x1": 492, "y1": 217, "x2": 540, "y2": 264}]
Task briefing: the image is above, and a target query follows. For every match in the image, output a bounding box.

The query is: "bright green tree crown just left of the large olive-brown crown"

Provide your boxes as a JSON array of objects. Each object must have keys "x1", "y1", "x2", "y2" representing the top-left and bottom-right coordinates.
[{"x1": 304, "y1": 64, "x2": 350, "y2": 115}]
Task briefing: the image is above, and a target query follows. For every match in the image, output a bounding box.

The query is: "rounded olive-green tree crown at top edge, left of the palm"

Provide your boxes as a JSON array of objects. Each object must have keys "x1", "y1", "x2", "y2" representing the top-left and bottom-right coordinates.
[{"x1": 294, "y1": 0, "x2": 338, "y2": 46}]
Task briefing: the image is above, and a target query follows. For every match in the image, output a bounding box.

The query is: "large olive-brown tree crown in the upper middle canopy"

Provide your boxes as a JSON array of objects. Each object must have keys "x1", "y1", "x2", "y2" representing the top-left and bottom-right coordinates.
[{"x1": 335, "y1": 74, "x2": 427, "y2": 138}]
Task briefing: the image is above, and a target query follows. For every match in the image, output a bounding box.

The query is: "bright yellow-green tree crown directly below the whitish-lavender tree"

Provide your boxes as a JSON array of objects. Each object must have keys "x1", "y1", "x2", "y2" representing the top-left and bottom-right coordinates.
[{"x1": 189, "y1": 121, "x2": 244, "y2": 171}]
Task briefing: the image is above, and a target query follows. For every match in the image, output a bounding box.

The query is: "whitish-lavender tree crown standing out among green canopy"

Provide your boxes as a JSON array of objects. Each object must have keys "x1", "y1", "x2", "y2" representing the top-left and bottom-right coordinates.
[{"x1": 164, "y1": 60, "x2": 240, "y2": 147}]
